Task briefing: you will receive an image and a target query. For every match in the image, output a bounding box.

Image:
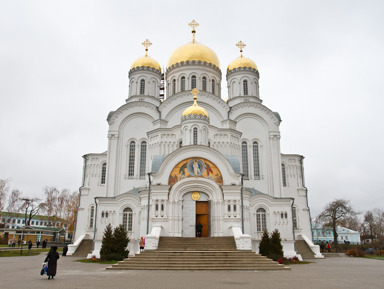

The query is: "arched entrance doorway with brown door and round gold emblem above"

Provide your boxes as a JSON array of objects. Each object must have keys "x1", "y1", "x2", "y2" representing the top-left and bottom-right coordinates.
[{"x1": 182, "y1": 191, "x2": 211, "y2": 237}]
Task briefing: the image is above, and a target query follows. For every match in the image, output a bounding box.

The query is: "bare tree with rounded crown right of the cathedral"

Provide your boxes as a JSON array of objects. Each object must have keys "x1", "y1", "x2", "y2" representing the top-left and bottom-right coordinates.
[{"x1": 317, "y1": 199, "x2": 358, "y2": 251}]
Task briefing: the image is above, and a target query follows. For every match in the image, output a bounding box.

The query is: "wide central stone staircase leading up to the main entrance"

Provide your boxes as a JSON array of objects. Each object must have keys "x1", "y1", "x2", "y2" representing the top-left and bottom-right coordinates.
[{"x1": 107, "y1": 237, "x2": 289, "y2": 270}]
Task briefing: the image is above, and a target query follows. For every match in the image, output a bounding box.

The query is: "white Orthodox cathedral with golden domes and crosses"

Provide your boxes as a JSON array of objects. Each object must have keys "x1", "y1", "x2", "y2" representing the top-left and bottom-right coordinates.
[{"x1": 70, "y1": 21, "x2": 318, "y2": 256}]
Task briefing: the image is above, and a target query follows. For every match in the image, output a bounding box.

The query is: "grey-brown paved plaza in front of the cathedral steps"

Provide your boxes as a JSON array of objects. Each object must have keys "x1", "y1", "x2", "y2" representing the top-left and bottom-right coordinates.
[{"x1": 0, "y1": 254, "x2": 384, "y2": 289}]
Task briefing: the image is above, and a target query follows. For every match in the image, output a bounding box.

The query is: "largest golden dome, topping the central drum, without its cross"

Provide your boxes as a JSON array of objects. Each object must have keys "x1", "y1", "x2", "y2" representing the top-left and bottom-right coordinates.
[{"x1": 167, "y1": 42, "x2": 220, "y2": 68}]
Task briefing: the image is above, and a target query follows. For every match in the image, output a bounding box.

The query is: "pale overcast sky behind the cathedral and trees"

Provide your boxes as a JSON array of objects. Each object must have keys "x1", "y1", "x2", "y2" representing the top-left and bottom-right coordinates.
[{"x1": 0, "y1": 0, "x2": 384, "y2": 216}]
